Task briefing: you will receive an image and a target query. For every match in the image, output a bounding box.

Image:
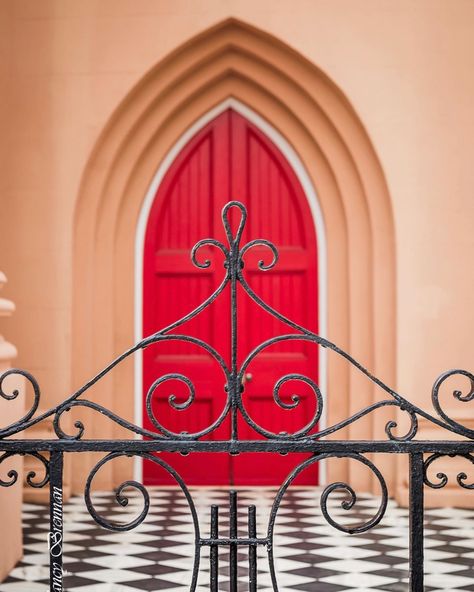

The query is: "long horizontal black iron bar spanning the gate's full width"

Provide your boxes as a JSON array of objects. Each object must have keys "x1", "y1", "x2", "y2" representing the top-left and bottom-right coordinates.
[{"x1": 0, "y1": 438, "x2": 474, "y2": 455}]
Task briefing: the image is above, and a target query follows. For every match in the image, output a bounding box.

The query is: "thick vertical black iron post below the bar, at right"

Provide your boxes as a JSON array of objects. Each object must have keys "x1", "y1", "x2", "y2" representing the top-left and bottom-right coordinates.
[{"x1": 409, "y1": 452, "x2": 424, "y2": 592}]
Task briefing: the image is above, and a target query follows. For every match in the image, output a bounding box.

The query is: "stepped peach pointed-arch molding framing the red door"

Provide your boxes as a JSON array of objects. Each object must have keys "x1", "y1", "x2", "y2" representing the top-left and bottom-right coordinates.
[{"x1": 73, "y1": 20, "x2": 395, "y2": 488}]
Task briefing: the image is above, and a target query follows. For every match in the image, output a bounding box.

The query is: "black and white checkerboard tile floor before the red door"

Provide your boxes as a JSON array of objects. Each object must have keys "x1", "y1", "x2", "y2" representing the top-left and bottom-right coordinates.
[{"x1": 0, "y1": 488, "x2": 474, "y2": 592}]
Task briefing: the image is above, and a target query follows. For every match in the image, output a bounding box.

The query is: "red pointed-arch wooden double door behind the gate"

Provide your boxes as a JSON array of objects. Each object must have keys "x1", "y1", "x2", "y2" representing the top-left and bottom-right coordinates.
[{"x1": 143, "y1": 109, "x2": 318, "y2": 485}]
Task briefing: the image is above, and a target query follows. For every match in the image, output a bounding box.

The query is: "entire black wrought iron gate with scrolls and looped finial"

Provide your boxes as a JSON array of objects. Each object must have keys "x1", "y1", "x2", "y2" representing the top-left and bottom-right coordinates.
[{"x1": 0, "y1": 201, "x2": 474, "y2": 592}]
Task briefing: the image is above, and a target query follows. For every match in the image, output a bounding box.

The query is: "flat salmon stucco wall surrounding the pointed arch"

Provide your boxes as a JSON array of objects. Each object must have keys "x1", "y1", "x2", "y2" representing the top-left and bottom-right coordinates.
[{"x1": 0, "y1": 0, "x2": 474, "y2": 504}]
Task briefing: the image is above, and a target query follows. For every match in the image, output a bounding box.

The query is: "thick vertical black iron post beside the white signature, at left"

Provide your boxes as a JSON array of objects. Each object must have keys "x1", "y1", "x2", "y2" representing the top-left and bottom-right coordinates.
[{"x1": 49, "y1": 451, "x2": 63, "y2": 592}]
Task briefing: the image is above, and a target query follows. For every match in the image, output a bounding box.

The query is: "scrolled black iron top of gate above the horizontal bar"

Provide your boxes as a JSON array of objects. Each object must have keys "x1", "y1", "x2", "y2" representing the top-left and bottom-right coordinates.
[{"x1": 0, "y1": 201, "x2": 474, "y2": 441}]
